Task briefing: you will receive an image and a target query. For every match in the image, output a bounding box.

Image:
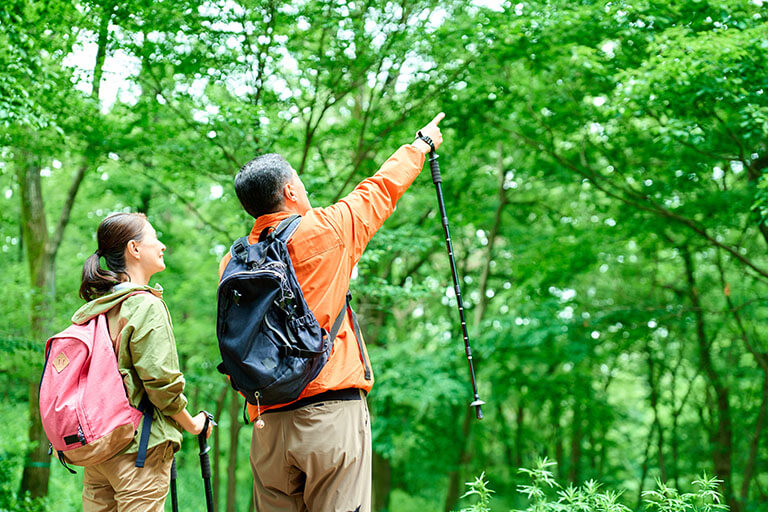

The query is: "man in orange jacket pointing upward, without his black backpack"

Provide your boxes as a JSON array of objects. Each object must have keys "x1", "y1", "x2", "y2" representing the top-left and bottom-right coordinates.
[{"x1": 219, "y1": 113, "x2": 444, "y2": 512}]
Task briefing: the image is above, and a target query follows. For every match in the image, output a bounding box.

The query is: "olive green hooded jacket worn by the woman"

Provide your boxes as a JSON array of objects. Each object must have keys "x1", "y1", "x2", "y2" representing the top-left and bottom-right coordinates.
[{"x1": 72, "y1": 283, "x2": 187, "y2": 453}]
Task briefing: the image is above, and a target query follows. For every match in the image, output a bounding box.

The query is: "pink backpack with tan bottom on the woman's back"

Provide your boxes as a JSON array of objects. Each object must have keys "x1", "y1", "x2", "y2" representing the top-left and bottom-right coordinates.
[{"x1": 40, "y1": 314, "x2": 152, "y2": 471}]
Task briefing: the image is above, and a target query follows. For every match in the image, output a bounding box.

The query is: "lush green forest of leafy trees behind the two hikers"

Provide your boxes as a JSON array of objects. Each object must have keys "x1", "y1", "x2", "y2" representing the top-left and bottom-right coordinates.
[{"x1": 0, "y1": 0, "x2": 768, "y2": 511}]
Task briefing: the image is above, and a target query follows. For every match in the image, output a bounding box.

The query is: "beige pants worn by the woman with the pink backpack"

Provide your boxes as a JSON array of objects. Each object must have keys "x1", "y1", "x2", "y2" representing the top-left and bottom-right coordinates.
[{"x1": 83, "y1": 442, "x2": 173, "y2": 512}]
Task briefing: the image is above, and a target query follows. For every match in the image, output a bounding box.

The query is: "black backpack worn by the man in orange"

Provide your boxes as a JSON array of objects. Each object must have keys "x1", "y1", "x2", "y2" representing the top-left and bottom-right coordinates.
[{"x1": 216, "y1": 215, "x2": 348, "y2": 405}]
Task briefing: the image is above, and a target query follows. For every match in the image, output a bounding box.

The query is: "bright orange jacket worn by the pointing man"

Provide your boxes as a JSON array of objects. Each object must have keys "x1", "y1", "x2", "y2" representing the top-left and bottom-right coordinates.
[{"x1": 219, "y1": 145, "x2": 424, "y2": 421}]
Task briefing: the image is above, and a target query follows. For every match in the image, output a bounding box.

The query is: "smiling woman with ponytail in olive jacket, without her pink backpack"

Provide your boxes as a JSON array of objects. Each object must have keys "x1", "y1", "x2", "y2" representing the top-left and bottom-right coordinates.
[{"x1": 72, "y1": 213, "x2": 211, "y2": 512}]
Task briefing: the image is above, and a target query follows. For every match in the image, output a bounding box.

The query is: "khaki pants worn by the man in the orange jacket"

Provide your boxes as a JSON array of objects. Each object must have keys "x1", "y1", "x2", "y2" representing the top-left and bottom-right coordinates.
[{"x1": 250, "y1": 391, "x2": 371, "y2": 512}]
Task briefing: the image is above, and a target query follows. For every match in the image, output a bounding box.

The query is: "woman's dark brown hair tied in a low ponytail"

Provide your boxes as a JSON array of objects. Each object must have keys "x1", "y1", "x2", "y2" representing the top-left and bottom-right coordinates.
[{"x1": 80, "y1": 213, "x2": 147, "y2": 301}]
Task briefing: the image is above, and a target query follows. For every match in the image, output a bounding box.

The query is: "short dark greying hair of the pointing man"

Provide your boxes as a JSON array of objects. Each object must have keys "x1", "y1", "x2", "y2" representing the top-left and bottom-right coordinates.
[{"x1": 235, "y1": 153, "x2": 293, "y2": 217}]
